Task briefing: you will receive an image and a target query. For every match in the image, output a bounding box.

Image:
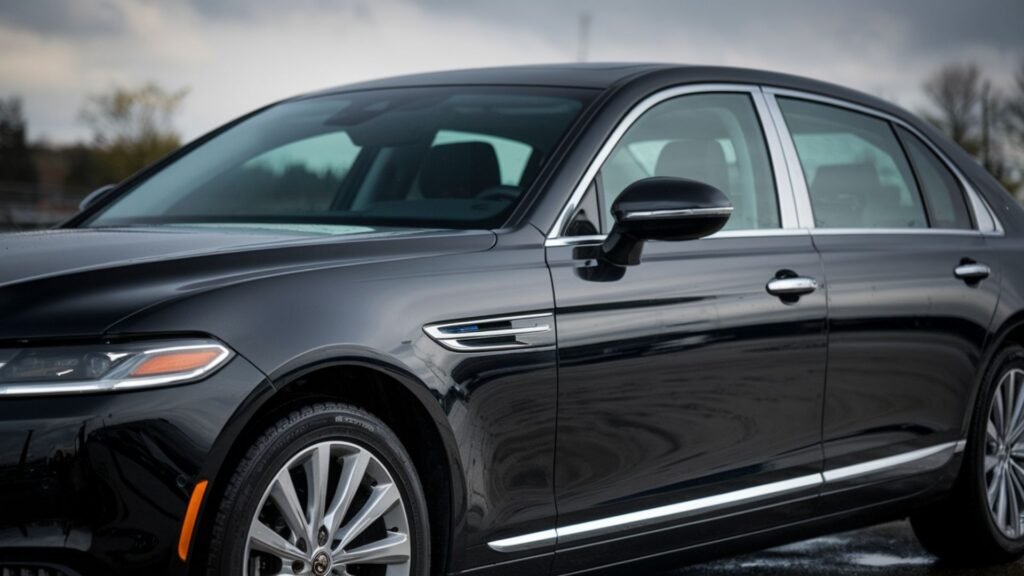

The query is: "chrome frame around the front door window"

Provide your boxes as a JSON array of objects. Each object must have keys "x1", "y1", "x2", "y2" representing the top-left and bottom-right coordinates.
[{"x1": 548, "y1": 84, "x2": 797, "y2": 240}]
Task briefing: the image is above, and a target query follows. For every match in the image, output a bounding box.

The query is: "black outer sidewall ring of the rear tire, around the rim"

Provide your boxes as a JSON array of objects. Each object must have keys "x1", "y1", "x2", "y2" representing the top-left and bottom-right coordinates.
[{"x1": 970, "y1": 345, "x2": 1024, "y2": 556}]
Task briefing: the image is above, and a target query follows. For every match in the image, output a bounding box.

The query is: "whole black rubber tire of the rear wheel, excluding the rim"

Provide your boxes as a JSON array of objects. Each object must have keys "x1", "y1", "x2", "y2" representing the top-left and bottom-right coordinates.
[{"x1": 910, "y1": 344, "x2": 1024, "y2": 566}]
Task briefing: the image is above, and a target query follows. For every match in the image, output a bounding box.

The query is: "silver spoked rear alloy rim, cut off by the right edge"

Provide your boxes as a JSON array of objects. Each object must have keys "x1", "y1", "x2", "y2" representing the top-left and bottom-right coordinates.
[{"x1": 985, "y1": 369, "x2": 1024, "y2": 539}]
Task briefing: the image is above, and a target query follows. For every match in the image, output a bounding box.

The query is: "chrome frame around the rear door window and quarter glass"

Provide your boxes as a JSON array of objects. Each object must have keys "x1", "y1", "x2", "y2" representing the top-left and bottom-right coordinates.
[{"x1": 763, "y1": 86, "x2": 1004, "y2": 236}]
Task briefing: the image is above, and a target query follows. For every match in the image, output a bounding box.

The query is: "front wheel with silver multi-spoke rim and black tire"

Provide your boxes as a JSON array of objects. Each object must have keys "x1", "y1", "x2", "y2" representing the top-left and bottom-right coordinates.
[{"x1": 207, "y1": 404, "x2": 430, "y2": 576}]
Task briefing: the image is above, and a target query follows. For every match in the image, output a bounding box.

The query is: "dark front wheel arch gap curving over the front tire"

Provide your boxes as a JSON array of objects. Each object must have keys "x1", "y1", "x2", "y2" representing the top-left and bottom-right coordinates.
[{"x1": 188, "y1": 346, "x2": 466, "y2": 574}]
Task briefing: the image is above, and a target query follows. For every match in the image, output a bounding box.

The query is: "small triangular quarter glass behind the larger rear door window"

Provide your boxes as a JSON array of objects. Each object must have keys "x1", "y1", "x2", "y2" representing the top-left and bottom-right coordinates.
[{"x1": 896, "y1": 126, "x2": 974, "y2": 230}]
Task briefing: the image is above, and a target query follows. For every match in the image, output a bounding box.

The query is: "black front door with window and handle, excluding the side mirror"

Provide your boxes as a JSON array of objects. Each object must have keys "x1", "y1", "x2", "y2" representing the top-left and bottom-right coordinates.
[{"x1": 548, "y1": 89, "x2": 826, "y2": 573}]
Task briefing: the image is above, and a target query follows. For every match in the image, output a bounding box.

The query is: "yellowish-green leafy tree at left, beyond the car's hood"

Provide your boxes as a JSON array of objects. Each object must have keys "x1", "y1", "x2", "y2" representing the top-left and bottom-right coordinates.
[{"x1": 79, "y1": 83, "x2": 188, "y2": 182}]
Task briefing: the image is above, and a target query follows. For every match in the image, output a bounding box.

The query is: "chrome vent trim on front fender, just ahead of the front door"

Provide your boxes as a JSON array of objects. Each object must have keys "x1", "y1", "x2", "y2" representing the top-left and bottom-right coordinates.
[{"x1": 423, "y1": 313, "x2": 555, "y2": 352}]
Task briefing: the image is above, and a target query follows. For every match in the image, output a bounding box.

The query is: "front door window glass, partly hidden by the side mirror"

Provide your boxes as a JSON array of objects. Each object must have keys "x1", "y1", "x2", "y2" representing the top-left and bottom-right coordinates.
[{"x1": 597, "y1": 94, "x2": 779, "y2": 232}]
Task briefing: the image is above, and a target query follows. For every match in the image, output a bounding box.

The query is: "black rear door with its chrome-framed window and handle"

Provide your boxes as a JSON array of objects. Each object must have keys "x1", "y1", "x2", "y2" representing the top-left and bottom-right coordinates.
[{"x1": 769, "y1": 90, "x2": 998, "y2": 512}]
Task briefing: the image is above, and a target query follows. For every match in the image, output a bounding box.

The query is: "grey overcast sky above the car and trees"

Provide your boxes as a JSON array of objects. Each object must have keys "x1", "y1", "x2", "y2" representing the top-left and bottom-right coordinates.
[{"x1": 0, "y1": 0, "x2": 1024, "y2": 141}]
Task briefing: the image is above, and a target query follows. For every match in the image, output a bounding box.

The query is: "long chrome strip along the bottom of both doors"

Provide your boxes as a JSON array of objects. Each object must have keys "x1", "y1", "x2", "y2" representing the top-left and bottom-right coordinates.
[{"x1": 487, "y1": 440, "x2": 967, "y2": 552}]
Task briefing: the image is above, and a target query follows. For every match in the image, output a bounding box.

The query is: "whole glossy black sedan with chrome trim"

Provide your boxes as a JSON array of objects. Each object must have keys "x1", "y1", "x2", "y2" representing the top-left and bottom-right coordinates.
[{"x1": 0, "y1": 65, "x2": 1024, "y2": 576}]
